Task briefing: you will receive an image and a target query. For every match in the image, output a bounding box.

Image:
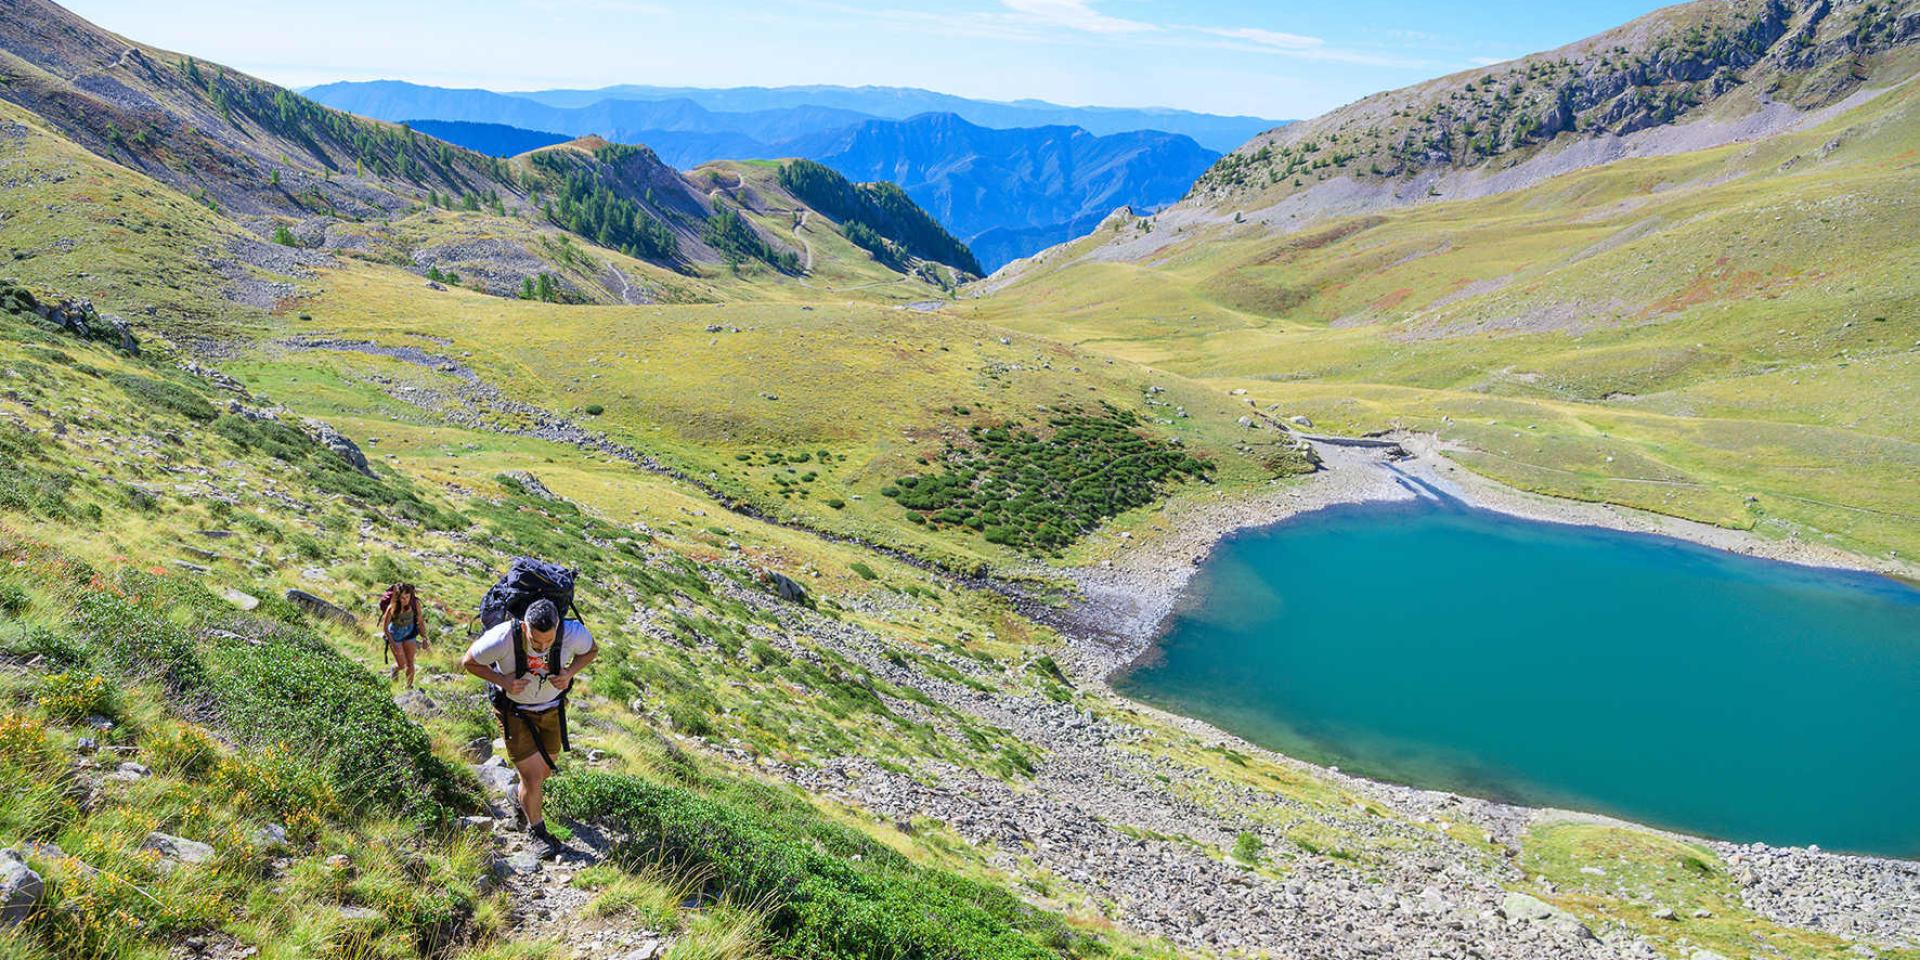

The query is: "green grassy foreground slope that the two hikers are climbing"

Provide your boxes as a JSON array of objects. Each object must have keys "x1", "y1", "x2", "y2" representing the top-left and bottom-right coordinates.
[{"x1": 0, "y1": 307, "x2": 1899, "y2": 960}]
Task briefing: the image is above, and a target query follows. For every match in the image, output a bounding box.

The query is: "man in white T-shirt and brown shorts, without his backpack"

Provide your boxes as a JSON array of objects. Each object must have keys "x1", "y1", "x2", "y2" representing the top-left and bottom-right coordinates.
[{"x1": 461, "y1": 595, "x2": 599, "y2": 856}]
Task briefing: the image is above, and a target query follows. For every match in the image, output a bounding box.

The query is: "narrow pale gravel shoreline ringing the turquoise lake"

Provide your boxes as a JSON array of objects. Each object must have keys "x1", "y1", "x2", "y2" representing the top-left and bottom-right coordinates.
[{"x1": 1035, "y1": 436, "x2": 1920, "y2": 947}]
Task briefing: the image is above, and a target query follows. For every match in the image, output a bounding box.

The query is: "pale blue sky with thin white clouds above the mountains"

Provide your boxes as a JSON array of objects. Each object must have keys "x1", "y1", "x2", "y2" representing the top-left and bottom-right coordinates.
[{"x1": 67, "y1": 0, "x2": 1661, "y2": 119}]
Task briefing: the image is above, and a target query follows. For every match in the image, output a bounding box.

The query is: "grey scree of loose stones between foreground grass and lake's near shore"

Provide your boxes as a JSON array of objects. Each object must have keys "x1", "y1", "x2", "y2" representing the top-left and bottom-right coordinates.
[{"x1": 675, "y1": 526, "x2": 1920, "y2": 958}]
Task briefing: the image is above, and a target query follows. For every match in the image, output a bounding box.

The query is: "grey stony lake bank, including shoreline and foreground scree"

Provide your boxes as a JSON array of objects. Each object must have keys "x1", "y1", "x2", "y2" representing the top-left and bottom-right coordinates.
[{"x1": 910, "y1": 438, "x2": 1920, "y2": 960}]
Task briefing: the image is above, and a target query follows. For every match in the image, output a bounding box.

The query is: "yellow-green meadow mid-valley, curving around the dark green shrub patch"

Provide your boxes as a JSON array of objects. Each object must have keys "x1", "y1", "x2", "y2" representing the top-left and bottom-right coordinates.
[{"x1": 243, "y1": 265, "x2": 1305, "y2": 566}]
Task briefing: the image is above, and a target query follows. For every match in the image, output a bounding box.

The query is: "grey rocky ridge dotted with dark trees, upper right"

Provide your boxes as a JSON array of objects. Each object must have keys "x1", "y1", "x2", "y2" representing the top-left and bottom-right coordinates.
[{"x1": 1188, "y1": 0, "x2": 1920, "y2": 211}]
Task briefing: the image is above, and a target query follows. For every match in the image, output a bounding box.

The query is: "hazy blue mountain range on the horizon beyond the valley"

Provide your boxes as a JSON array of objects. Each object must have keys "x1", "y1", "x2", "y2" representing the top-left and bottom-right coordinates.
[{"x1": 305, "y1": 81, "x2": 1279, "y2": 271}]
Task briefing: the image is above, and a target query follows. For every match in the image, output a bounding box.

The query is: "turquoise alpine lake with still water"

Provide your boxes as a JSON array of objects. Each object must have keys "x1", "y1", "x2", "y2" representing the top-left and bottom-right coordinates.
[{"x1": 1116, "y1": 501, "x2": 1920, "y2": 856}]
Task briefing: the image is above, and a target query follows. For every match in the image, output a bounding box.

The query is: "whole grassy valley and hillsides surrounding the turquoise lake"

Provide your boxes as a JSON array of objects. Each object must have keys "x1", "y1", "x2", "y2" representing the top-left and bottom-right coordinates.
[{"x1": 0, "y1": 0, "x2": 1920, "y2": 960}]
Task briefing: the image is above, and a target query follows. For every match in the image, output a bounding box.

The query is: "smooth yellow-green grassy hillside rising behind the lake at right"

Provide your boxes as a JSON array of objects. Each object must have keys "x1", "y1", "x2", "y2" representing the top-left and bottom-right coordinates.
[{"x1": 960, "y1": 76, "x2": 1920, "y2": 557}]
